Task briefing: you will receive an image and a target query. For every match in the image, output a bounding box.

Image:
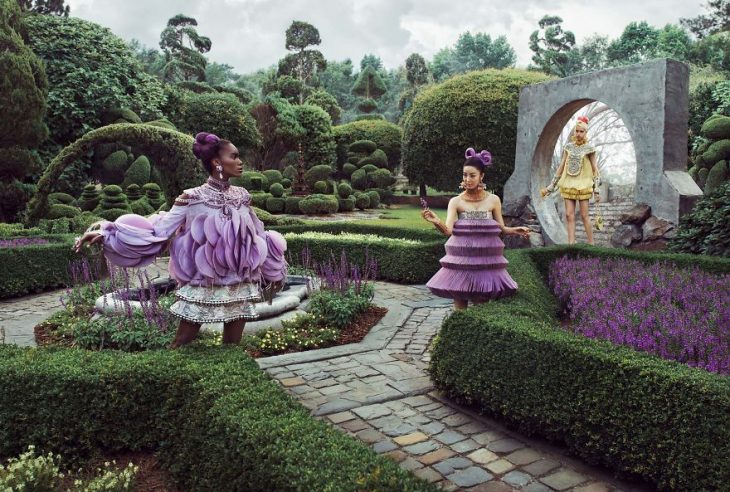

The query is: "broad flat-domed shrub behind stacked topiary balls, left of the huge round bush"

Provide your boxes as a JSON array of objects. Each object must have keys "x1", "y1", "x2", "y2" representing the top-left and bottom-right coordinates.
[{"x1": 332, "y1": 120, "x2": 400, "y2": 170}]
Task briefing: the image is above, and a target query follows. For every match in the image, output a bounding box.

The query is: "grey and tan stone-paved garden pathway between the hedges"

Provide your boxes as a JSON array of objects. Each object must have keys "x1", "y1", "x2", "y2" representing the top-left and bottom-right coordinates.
[{"x1": 0, "y1": 276, "x2": 649, "y2": 492}]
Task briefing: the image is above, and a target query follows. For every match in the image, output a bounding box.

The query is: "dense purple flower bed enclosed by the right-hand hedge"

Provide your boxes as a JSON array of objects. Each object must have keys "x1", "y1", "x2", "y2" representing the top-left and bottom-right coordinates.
[{"x1": 550, "y1": 257, "x2": 730, "y2": 374}]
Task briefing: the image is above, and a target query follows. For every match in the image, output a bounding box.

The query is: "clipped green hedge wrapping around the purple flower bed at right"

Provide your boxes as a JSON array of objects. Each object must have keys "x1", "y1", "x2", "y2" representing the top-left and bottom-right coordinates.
[{"x1": 430, "y1": 247, "x2": 730, "y2": 490}]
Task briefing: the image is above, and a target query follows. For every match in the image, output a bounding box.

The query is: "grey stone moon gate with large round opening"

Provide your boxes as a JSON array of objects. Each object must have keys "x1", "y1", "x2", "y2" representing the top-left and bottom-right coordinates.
[{"x1": 504, "y1": 59, "x2": 702, "y2": 244}]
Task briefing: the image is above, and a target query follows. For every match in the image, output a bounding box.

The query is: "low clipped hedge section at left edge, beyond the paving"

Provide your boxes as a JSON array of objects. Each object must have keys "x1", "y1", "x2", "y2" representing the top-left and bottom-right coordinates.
[{"x1": 0, "y1": 234, "x2": 96, "y2": 299}]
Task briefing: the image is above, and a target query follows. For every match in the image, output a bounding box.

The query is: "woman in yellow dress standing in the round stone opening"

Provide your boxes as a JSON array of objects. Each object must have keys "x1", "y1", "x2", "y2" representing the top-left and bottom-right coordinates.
[{"x1": 540, "y1": 116, "x2": 601, "y2": 244}]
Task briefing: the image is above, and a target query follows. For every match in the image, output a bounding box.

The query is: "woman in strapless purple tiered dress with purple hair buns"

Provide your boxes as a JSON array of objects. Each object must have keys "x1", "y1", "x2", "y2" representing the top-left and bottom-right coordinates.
[{"x1": 421, "y1": 148, "x2": 530, "y2": 309}]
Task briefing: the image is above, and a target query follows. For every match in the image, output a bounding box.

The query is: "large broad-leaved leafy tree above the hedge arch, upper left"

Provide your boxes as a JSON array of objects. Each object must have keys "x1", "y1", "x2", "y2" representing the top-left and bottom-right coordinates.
[{"x1": 27, "y1": 15, "x2": 164, "y2": 145}]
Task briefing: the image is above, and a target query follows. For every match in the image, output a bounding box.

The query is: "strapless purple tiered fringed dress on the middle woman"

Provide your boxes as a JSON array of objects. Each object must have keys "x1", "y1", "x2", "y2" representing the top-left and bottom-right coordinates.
[{"x1": 426, "y1": 211, "x2": 517, "y2": 301}]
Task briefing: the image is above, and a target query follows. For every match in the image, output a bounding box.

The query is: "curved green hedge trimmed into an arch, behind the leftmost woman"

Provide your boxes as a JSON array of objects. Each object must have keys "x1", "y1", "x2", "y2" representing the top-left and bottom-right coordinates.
[{"x1": 25, "y1": 123, "x2": 206, "y2": 224}]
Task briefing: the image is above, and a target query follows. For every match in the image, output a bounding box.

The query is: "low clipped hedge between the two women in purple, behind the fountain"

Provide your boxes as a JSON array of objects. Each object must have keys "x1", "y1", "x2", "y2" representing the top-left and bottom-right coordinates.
[{"x1": 273, "y1": 222, "x2": 445, "y2": 284}]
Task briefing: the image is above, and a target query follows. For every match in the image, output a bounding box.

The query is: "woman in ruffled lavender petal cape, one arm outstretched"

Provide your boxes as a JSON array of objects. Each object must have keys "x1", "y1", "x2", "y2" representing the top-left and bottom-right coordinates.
[{"x1": 76, "y1": 133, "x2": 287, "y2": 347}]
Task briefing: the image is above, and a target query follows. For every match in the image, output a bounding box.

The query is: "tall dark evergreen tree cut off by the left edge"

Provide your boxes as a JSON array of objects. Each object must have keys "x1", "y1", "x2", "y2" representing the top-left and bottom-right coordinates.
[{"x1": 0, "y1": 0, "x2": 48, "y2": 222}]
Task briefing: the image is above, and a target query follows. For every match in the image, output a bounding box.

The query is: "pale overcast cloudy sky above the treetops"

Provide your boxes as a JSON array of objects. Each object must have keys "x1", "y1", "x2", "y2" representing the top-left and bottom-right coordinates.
[{"x1": 66, "y1": 0, "x2": 705, "y2": 73}]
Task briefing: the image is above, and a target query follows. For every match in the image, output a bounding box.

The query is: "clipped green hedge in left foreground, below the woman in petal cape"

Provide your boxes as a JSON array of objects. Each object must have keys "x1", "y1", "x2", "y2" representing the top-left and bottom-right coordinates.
[{"x1": 0, "y1": 346, "x2": 437, "y2": 491}]
